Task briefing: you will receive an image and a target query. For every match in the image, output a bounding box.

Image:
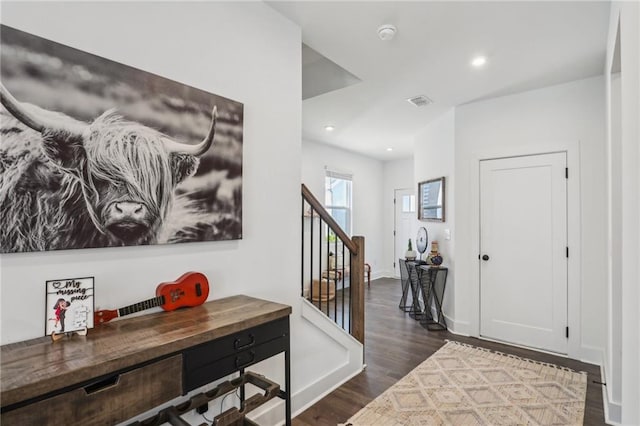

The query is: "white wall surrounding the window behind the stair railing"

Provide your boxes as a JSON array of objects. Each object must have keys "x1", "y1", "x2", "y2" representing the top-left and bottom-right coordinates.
[{"x1": 297, "y1": 140, "x2": 383, "y2": 278}]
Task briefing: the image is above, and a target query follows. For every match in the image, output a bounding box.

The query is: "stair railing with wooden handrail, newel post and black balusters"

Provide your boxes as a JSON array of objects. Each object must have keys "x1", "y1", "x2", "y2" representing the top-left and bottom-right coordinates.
[{"x1": 300, "y1": 184, "x2": 365, "y2": 344}]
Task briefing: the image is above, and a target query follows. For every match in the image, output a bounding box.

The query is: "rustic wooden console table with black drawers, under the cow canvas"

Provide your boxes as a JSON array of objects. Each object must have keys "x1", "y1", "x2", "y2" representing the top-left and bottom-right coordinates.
[{"x1": 0, "y1": 295, "x2": 291, "y2": 426}]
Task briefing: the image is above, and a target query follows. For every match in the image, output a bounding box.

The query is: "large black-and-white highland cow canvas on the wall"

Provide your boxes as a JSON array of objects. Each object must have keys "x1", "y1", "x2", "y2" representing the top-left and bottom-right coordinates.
[{"x1": 0, "y1": 26, "x2": 243, "y2": 253}]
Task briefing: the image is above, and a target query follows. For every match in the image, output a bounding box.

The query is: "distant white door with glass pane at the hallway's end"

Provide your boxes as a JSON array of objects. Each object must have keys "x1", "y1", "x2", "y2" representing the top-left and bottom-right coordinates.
[{"x1": 393, "y1": 189, "x2": 416, "y2": 278}]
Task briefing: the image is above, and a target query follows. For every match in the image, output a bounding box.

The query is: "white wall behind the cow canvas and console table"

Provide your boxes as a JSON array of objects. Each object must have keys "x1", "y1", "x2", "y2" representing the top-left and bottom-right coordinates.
[{"x1": 0, "y1": 2, "x2": 358, "y2": 424}]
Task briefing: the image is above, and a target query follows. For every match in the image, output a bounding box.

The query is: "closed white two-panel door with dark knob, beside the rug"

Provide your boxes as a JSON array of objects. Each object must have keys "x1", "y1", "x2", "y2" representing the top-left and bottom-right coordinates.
[{"x1": 480, "y1": 152, "x2": 568, "y2": 354}]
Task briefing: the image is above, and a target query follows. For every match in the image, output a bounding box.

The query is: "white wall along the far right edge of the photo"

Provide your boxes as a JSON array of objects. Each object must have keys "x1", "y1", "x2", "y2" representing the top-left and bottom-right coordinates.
[{"x1": 605, "y1": 2, "x2": 640, "y2": 425}]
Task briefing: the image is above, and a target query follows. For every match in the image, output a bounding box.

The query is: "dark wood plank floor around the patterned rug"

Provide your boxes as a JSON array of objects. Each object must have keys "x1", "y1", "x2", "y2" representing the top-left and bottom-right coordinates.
[{"x1": 293, "y1": 278, "x2": 605, "y2": 426}]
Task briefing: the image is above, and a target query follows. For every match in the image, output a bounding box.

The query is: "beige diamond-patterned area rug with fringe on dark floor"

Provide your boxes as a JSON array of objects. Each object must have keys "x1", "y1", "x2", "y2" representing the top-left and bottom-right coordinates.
[{"x1": 345, "y1": 341, "x2": 587, "y2": 426}]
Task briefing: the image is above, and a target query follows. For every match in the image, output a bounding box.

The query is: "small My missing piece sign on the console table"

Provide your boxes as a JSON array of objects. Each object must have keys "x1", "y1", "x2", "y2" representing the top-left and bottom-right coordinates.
[{"x1": 45, "y1": 277, "x2": 95, "y2": 336}]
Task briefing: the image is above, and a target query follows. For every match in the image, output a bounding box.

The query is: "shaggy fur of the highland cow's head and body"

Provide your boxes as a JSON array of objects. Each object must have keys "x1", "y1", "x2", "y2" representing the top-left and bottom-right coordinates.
[{"x1": 0, "y1": 110, "x2": 198, "y2": 252}]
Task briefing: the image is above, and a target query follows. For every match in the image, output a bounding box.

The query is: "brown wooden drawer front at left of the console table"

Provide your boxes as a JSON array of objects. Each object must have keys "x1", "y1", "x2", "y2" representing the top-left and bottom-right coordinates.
[{"x1": 1, "y1": 355, "x2": 182, "y2": 426}]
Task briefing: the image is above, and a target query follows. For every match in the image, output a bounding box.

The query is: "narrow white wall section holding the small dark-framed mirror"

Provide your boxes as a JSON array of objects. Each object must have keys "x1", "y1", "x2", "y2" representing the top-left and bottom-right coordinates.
[{"x1": 413, "y1": 109, "x2": 456, "y2": 326}]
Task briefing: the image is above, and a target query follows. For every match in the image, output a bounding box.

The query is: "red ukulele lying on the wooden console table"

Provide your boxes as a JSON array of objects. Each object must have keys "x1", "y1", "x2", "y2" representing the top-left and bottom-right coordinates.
[{"x1": 93, "y1": 272, "x2": 209, "y2": 325}]
